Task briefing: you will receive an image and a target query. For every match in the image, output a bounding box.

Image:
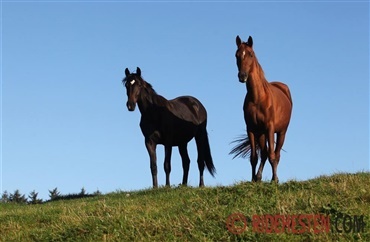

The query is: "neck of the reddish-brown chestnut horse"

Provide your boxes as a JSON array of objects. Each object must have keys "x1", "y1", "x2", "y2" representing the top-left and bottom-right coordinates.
[{"x1": 246, "y1": 60, "x2": 268, "y2": 103}]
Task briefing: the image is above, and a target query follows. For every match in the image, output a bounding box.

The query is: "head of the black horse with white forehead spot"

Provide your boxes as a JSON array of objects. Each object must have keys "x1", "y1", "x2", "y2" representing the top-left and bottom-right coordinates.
[{"x1": 122, "y1": 67, "x2": 144, "y2": 111}]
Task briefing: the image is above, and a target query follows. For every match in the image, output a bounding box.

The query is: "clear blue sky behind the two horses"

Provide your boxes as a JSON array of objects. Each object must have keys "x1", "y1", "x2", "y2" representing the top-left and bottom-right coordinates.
[{"x1": 0, "y1": 1, "x2": 369, "y2": 199}]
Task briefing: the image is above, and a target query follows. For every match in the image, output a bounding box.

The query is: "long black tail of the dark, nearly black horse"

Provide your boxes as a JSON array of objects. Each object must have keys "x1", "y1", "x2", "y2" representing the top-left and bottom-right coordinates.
[{"x1": 196, "y1": 122, "x2": 216, "y2": 177}]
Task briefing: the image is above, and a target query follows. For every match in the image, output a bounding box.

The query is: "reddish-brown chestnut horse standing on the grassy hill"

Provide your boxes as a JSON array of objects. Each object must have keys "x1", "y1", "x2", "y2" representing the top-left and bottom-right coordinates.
[{"x1": 230, "y1": 36, "x2": 293, "y2": 182}]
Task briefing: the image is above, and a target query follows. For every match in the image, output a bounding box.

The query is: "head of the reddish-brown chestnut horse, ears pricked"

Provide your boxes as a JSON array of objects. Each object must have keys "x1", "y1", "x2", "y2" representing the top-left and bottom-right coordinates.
[{"x1": 235, "y1": 35, "x2": 255, "y2": 83}]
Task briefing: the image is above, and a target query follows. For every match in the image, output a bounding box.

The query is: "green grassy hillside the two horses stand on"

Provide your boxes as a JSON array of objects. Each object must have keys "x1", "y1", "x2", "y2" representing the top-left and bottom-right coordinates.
[{"x1": 0, "y1": 172, "x2": 370, "y2": 241}]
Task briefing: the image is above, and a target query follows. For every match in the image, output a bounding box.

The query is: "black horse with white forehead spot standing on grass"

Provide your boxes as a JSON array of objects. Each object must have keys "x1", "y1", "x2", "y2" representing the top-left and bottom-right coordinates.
[{"x1": 123, "y1": 67, "x2": 216, "y2": 187}]
